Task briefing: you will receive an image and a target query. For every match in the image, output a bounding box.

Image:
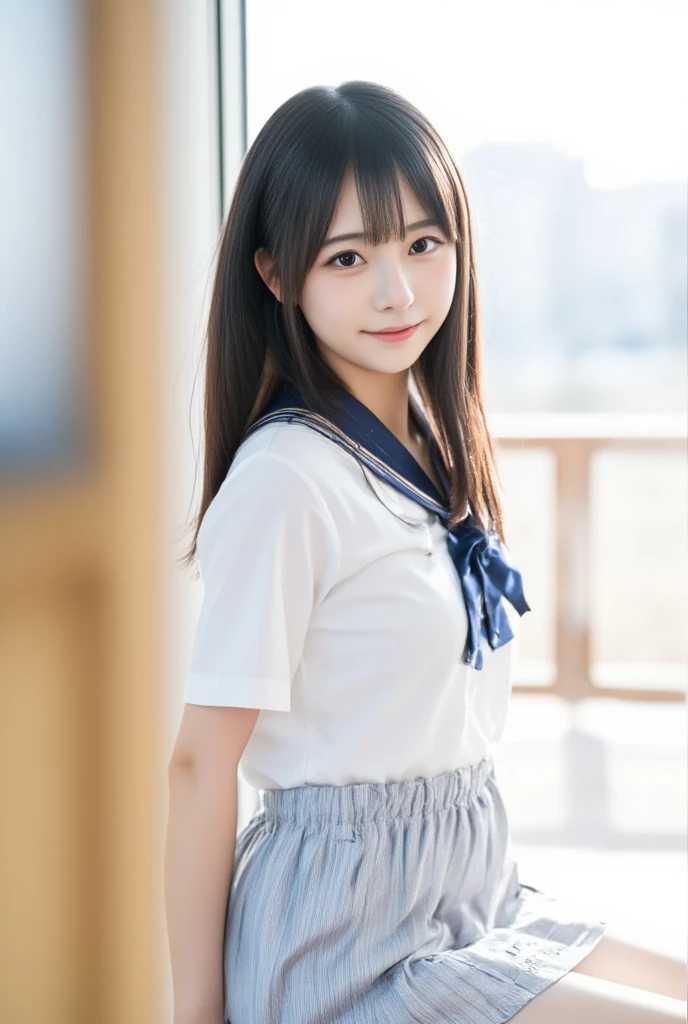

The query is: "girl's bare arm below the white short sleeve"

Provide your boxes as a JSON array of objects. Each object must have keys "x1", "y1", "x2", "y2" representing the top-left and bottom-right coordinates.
[{"x1": 165, "y1": 705, "x2": 259, "y2": 1024}]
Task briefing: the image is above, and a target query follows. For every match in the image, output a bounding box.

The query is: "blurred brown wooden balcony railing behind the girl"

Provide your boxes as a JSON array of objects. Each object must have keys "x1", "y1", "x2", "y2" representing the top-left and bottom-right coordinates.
[{"x1": 490, "y1": 415, "x2": 688, "y2": 701}]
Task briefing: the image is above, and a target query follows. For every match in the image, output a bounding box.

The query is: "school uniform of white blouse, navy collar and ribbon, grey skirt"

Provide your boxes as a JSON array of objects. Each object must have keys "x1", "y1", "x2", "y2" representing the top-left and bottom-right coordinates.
[{"x1": 184, "y1": 388, "x2": 606, "y2": 1024}]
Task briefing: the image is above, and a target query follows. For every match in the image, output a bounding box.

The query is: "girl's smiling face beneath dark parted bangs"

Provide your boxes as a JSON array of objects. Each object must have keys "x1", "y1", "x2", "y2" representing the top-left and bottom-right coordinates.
[{"x1": 256, "y1": 167, "x2": 457, "y2": 392}]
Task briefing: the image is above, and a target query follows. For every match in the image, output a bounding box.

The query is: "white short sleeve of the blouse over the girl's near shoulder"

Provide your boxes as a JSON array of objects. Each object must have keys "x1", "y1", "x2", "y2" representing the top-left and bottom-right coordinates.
[{"x1": 184, "y1": 452, "x2": 339, "y2": 711}]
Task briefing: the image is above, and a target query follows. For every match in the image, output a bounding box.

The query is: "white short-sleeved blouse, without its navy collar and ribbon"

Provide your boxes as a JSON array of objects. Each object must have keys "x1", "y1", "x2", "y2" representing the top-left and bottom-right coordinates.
[{"x1": 184, "y1": 421, "x2": 520, "y2": 787}]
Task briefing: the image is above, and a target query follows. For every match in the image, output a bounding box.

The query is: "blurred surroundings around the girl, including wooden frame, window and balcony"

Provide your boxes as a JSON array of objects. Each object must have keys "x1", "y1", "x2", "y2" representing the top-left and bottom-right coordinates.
[{"x1": 0, "y1": 0, "x2": 688, "y2": 1024}]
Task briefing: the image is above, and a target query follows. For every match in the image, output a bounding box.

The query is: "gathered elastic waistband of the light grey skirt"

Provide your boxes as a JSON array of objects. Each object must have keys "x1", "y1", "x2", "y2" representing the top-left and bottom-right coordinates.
[{"x1": 258, "y1": 757, "x2": 495, "y2": 824}]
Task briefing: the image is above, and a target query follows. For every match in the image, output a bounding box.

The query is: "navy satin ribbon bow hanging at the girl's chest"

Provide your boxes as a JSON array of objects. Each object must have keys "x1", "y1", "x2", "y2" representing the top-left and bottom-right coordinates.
[{"x1": 446, "y1": 516, "x2": 530, "y2": 670}]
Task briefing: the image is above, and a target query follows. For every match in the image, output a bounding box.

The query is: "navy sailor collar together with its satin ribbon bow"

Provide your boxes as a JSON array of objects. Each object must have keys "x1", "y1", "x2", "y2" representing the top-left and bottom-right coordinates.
[{"x1": 246, "y1": 386, "x2": 530, "y2": 670}]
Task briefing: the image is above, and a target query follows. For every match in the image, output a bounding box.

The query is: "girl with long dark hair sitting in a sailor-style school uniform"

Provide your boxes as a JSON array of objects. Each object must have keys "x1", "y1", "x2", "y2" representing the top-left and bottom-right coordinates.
[{"x1": 166, "y1": 82, "x2": 685, "y2": 1024}]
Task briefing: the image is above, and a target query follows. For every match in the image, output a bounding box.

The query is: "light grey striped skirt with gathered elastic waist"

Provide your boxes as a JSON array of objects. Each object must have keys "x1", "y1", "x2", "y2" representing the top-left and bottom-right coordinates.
[{"x1": 224, "y1": 758, "x2": 606, "y2": 1024}]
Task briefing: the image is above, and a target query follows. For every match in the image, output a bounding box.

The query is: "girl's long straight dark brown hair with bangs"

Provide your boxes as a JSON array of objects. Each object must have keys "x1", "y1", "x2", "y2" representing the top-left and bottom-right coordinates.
[{"x1": 183, "y1": 81, "x2": 505, "y2": 564}]
